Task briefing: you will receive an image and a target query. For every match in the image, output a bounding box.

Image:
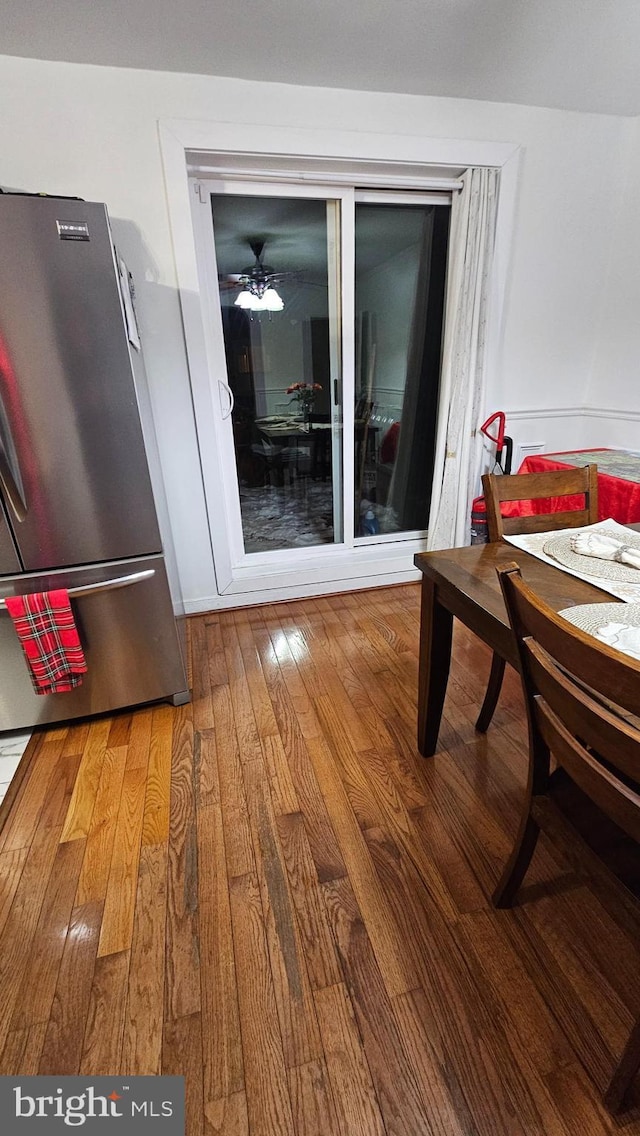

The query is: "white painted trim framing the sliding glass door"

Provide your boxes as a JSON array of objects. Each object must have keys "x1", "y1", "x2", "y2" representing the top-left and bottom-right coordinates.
[{"x1": 159, "y1": 119, "x2": 520, "y2": 607}]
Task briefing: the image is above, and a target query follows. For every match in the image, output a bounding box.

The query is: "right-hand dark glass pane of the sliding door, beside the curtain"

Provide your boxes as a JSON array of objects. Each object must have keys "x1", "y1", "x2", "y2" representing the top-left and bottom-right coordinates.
[{"x1": 354, "y1": 192, "x2": 450, "y2": 540}]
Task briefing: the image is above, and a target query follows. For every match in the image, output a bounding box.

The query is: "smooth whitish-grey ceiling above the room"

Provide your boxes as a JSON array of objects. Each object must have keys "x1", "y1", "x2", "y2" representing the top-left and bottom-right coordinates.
[{"x1": 0, "y1": 0, "x2": 640, "y2": 115}]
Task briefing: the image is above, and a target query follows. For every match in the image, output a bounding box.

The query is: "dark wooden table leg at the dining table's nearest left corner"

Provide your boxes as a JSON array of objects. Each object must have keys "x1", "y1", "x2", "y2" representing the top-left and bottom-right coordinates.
[{"x1": 418, "y1": 576, "x2": 454, "y2": 758}]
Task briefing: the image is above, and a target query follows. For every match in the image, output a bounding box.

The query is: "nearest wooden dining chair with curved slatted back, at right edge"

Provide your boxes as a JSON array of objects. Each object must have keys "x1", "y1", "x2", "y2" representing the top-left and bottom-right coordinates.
[{"x1": 493, "y1": 563, "x2": 640, "y2": 1112}]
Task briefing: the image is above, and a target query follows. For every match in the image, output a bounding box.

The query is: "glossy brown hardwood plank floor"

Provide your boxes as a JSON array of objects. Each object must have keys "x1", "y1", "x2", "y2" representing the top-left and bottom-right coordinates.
[{"x1": 0, "y1": 585, "x2": 640, "y2": 1136}]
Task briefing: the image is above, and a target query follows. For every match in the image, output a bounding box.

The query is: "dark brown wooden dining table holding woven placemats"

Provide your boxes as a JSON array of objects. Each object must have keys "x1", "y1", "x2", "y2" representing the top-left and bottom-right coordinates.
[{"x1": 414, "y1": 538, "x2": 627, "y2": 758}]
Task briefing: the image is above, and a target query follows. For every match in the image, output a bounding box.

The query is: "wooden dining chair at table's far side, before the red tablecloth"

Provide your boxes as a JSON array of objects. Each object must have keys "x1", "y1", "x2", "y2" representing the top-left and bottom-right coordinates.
[{"x1": 475, "y1": 465, "x2": 598, "y2": 734}]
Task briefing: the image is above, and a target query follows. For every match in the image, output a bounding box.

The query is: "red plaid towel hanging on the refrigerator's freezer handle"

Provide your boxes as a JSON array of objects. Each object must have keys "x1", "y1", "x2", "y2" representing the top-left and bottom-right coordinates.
[{"x1": 5, "y1": 587, "x2": 86, "y2": 694}]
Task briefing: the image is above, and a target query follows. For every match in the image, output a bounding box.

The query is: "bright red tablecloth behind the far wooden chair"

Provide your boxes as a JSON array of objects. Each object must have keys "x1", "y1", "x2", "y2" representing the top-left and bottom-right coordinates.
[{"x1": 513, "y1": 449, "x2": 640, "y2": 525}]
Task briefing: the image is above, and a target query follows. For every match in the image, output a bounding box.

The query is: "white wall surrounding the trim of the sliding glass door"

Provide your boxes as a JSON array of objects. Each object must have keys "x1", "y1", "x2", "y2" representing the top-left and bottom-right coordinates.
[{"x1": 0, "y1": 57, "x2": 638, "y2": 604}]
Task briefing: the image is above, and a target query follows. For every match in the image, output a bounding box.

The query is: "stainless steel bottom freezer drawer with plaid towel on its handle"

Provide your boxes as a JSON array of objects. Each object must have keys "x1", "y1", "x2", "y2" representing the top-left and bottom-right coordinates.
[{"x1": 0, "y1": 557, "x2": 189, "y2": 730}]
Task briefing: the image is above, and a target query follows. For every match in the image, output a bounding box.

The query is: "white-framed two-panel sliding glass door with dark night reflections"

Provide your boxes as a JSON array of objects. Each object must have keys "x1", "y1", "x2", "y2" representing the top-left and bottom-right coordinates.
[{"x1": 189, "y1": 182, "x2": 450, "y2": 591}]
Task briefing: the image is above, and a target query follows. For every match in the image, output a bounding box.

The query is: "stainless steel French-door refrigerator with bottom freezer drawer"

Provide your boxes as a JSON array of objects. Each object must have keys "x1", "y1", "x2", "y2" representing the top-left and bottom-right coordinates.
[{"x1": 0, "y1": 194, "x2": 189, "y2": 730}]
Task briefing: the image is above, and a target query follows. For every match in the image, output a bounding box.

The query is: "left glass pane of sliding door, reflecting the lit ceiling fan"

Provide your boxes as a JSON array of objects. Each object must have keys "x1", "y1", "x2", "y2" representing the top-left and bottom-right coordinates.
[{"x1": 210, "y1": 193, "x2": 343, "y2": 553}]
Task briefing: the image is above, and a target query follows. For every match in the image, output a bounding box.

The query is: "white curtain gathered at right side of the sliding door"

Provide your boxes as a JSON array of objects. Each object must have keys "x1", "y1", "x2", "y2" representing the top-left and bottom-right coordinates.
[{"x1": 426, "y1": 168, "x2": 499, "y2": 551}]
